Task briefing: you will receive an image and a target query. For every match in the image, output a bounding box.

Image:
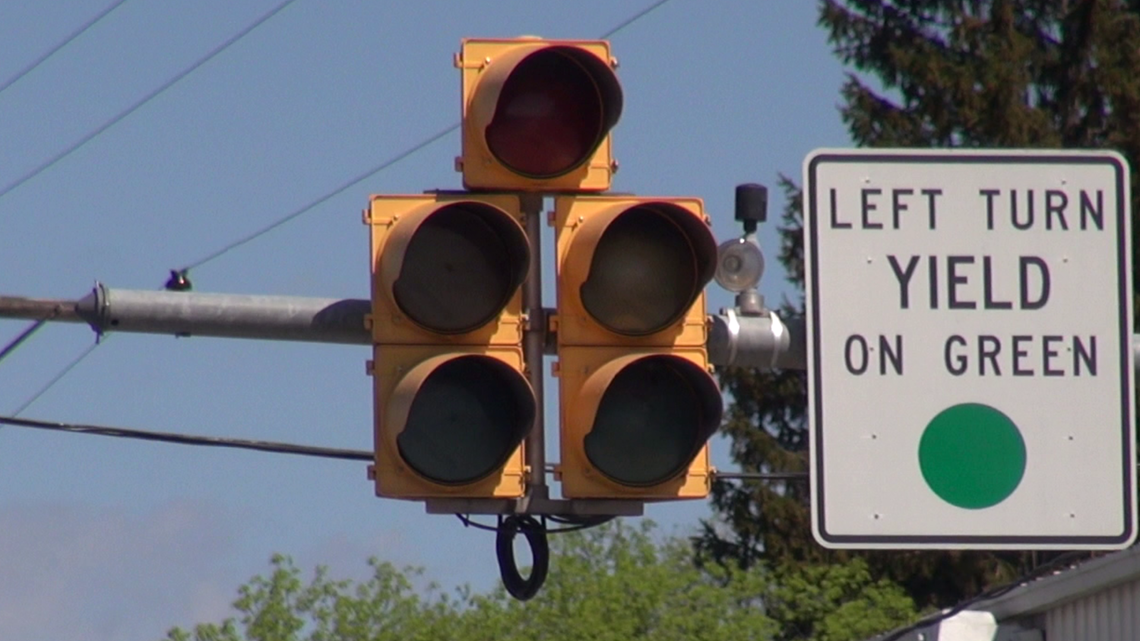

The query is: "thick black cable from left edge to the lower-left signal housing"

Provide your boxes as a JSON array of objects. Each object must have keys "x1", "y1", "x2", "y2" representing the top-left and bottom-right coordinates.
[{"x1": 0, "y1": 416, "x2": 375, "y2": 461}]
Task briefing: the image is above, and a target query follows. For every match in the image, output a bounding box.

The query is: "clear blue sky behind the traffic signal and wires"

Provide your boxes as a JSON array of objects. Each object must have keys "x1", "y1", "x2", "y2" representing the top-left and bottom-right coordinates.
[{"x1": 0, "y1": 0, "x2": 849, "y2": 640}]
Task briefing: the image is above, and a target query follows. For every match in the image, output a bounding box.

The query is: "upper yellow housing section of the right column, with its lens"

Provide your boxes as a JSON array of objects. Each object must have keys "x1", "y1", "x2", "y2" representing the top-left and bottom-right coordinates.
[{"x1": 554, "y1": 196, "x2": 716, "y2": 348}]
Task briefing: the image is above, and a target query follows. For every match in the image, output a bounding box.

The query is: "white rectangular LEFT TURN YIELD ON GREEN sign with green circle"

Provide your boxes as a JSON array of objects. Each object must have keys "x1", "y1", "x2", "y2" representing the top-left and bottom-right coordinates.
[{"x1": 804, "y1": 149, "x2": 1137, "y2": 549}]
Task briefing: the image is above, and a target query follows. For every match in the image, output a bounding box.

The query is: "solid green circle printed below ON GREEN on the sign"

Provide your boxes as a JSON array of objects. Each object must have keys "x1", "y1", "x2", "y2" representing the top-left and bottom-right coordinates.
[{"x1": 919, "y1": 403, "x2": 1025, "y2": 510}]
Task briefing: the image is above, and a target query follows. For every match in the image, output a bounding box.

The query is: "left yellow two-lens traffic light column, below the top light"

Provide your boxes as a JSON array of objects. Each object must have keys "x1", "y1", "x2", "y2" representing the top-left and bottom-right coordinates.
[{"x1": 365, "y1": 194, "x2": 536, "y2": 498}]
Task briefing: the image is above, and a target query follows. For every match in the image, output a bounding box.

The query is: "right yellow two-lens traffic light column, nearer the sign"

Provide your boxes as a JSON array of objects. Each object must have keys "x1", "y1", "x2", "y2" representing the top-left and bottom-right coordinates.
[{"x1": 554, "y1": 195, "x2": 723, "y2": 500}]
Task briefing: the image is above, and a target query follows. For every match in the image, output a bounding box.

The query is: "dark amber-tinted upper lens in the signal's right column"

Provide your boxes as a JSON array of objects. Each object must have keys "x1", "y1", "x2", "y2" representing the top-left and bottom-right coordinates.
[{"x1": 580, "y1": 203, "x2": 710, "y2": 335}]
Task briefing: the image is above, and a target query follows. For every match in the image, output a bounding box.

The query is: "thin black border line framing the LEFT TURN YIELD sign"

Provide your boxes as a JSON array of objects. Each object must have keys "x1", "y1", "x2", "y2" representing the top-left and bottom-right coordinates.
[{"x1": 804, "y1": 152, "x2": 1137, "y2": 549}]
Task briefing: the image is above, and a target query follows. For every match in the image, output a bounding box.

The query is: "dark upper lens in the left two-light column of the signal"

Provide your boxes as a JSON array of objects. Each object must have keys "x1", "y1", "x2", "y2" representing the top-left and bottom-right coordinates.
[{"x1": 392, "y1": 202, "x2": 529, "y2": 334}]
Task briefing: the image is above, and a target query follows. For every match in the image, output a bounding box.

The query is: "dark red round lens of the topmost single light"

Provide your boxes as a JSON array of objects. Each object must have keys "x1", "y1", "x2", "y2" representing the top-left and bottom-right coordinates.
[{"x1": 485, "y1": 47, "x2": 620, "y2": 178}]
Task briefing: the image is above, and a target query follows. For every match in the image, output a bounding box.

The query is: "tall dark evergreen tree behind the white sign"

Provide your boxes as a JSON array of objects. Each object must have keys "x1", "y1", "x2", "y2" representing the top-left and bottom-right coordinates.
[{"x1": 698, "y1": 0, "x2": 1140, "y2": 606}]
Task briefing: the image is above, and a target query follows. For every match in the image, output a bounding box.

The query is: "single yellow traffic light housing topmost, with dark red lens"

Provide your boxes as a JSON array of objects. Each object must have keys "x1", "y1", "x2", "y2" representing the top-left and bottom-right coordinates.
[{"x1": 455, "y1": 38, "x2": 621, "y2": 193}]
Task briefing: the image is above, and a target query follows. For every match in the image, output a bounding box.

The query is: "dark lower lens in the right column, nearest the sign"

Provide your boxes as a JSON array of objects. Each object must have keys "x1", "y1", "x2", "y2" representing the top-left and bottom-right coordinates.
[{"x1": 584, "y1": 356, "x2": 722, "y2": 486}]
